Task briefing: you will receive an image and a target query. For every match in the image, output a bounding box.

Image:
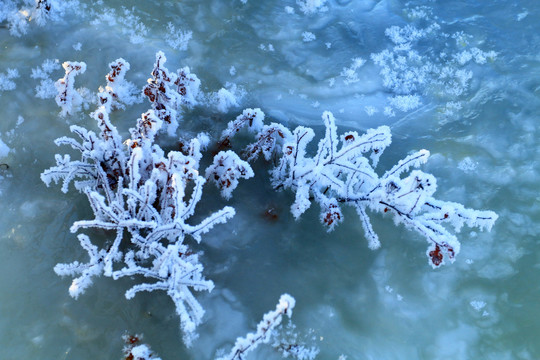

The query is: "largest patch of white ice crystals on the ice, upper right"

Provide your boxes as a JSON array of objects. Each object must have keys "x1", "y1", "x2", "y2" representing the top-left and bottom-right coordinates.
[{"x1": 371, "y1": 7, "x2": 497, "y2": 116}]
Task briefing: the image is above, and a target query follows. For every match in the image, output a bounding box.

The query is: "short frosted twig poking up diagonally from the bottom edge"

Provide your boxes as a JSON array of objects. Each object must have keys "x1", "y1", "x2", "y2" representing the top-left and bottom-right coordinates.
[{"x1": 217, "y1": 294, "x2": 296, "y2": 360}]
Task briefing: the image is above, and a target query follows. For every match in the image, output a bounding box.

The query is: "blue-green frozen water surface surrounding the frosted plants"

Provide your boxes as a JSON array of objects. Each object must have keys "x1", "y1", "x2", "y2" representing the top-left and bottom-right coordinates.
[{"x1": 0, "y1": 0, "x2": 540, "y2": 360}]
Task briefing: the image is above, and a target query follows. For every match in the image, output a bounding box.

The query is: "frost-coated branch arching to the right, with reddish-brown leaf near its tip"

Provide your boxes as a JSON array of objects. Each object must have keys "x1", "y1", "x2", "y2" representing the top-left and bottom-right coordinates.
[{"x1": 222, "y1": 109, "x2": 497, "y2": 268}]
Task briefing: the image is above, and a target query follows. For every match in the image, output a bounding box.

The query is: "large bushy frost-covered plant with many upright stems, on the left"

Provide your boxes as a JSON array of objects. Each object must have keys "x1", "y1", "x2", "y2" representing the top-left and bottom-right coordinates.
[{"x1": 41, "y1": 60, "x2": 234, "y2": 345}]
